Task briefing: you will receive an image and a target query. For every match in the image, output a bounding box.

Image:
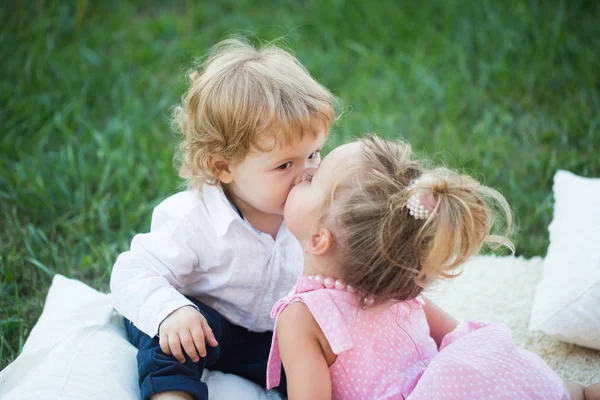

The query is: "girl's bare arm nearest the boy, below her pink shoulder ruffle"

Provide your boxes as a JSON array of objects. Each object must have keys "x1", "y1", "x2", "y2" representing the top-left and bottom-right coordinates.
[{"x1": 276, "y1": 302, "x2": 333, "y2": 400}]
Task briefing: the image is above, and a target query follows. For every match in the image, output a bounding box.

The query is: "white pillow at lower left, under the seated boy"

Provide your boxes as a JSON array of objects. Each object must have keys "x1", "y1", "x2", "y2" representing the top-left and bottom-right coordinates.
[{"x1": 0, "y1": 275, "x2": 279, "y2": 400}]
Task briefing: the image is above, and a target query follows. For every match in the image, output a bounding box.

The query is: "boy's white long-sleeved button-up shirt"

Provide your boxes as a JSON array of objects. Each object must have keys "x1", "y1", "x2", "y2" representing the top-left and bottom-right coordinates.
[{"x1": 110, "y1": 185, "x2": 303, "y2": 337}]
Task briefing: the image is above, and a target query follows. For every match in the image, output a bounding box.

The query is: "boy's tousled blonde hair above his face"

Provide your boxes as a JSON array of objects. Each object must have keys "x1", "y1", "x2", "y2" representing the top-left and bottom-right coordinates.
[{"x1": 173, "y1": 39, "x2": 335, "y2": 187}]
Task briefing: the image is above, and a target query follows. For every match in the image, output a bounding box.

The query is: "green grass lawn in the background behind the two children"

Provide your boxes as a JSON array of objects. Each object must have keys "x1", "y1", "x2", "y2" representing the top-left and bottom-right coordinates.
[{"x1": 0, "y1": 0, "x2": 600, "y2": 369}]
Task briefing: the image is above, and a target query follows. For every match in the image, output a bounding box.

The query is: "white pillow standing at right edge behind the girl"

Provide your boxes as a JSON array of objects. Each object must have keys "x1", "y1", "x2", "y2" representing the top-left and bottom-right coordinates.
[{"x1": 530, "y1": 171, "x2": 600, "y2": 349}]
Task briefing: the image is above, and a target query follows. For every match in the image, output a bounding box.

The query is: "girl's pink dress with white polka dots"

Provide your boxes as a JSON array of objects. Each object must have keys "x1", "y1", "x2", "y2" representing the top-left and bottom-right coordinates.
[{"x1": 267, "y1": 275, "x2": 569, "y2": 400}]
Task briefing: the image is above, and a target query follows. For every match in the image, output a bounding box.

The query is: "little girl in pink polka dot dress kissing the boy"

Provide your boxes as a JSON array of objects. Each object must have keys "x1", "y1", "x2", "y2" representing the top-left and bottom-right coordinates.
[{"x1": 267, "y1": 137, "x2": 598, "y2": 400}]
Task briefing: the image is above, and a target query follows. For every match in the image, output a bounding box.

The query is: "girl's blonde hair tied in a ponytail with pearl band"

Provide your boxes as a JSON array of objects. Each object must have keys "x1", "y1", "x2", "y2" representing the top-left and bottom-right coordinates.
[{"x1": 321, "y1": 136, "x2": 513, "y2": 302}]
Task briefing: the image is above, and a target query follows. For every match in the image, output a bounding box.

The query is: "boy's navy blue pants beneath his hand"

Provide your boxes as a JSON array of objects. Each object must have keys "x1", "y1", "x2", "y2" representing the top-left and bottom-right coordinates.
[{"x1": 125, "y1": 298, "x2": 285, "y2": 400}]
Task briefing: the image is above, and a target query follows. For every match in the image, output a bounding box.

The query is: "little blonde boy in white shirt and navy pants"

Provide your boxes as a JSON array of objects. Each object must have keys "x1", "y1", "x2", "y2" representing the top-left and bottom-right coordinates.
[{"x1": 111, "y1": 39, "x2": 335, "y2": 399}]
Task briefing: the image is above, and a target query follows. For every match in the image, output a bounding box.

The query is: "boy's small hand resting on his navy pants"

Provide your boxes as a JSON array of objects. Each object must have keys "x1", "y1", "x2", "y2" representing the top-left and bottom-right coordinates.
[{"x1": 159, "y1": 306, "x2": 219, "y2": 364}]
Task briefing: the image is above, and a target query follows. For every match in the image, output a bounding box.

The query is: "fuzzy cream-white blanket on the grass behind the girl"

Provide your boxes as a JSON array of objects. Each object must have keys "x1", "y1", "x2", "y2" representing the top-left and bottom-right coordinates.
[{"x1": 427, "y1": 256, "x2": 600, "y2": 384}]
